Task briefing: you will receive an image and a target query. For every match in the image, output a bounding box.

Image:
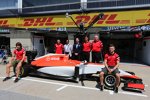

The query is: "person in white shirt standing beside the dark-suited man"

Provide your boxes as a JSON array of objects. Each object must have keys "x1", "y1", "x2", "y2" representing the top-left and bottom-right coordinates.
[{"x1": 64, "y1": 40, "x2": 72, "y2": 58}]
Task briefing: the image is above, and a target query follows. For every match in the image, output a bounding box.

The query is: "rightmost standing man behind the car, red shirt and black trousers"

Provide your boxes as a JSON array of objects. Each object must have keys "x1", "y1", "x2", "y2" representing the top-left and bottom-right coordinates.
[{"x1": 92, "y1": 35, "x2": 103, "y2": 63}]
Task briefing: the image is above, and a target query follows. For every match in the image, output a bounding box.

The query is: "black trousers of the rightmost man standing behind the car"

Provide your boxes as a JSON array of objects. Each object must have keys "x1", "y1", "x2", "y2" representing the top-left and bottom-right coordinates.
[{"x1": 92, "y1": 52, "x2": 102, "y2": 63}]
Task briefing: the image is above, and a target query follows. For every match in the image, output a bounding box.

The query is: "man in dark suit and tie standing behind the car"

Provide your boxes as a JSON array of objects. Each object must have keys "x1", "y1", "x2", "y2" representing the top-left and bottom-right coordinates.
[{"x1": 73, "y1": 38, "x2": 82, "y2": 60}]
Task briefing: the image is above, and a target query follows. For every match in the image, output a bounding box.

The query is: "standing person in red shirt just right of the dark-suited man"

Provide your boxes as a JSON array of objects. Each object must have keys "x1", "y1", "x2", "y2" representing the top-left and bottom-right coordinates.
[{"x1": 82, "y1": 36, "x2": 91, "y2": 62}]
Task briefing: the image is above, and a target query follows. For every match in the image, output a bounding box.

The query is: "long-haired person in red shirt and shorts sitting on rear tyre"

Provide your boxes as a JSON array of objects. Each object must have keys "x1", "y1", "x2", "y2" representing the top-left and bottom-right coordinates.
[{"x1": 3, "y1": 42, "x2": 26, "y2": 83}]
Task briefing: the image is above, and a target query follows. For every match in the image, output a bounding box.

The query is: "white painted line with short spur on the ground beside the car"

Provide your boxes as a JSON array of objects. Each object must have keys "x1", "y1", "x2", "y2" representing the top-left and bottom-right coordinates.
[{"x1": 0, "y1": 77, "x2": 148, "y2": 97}]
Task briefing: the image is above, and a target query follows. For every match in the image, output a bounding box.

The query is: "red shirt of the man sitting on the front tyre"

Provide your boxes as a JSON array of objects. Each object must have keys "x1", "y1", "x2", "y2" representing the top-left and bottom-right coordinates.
[{"x1": 104, "y1": 53, "x2": 120, "y2": 67}]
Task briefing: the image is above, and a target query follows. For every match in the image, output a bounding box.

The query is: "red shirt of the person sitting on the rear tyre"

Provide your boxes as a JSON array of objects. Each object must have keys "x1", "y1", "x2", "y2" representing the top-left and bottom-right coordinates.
[{"x1": 13, "y1": 48, "x2": 26, "y2": 61}]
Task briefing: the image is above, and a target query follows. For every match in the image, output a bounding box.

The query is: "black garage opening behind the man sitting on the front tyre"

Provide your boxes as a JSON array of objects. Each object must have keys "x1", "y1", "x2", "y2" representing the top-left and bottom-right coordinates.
[{"x1": 100, "y1": 32, "x2": 141, "y2": 62}]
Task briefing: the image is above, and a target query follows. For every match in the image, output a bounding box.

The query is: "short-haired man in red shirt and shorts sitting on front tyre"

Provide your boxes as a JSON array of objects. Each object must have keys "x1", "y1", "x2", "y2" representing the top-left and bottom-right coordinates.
[{"x1": 100, "y1": 44, "x2": 120, "y2": 93}]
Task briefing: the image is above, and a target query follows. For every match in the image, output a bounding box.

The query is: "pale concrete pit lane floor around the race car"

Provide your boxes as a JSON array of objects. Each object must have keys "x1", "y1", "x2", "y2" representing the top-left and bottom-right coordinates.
[{"x1": 0, "y1": 63, "x2": 150, "y2": 100}]
